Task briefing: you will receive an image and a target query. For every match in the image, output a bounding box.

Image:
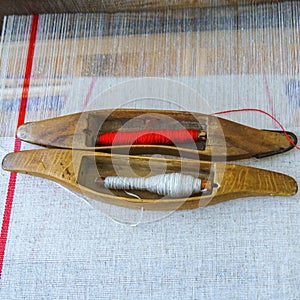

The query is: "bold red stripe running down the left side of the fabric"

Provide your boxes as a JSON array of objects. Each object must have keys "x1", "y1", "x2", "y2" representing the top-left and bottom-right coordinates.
[{"x1": 0, "y1": 15, "x2": 39, "y2": 278}]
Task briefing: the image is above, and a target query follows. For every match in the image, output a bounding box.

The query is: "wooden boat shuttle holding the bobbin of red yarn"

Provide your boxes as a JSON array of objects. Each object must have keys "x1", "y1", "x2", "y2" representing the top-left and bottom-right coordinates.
[{"x1": 17, "y1": 109, "x2": 297, "y2": 161}]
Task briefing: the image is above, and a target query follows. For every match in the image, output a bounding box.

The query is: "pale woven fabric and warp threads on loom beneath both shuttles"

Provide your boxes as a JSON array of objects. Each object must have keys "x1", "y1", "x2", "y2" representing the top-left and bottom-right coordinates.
[{"x1": 0, "y1": 2, "x2": 300, "y2": 299}]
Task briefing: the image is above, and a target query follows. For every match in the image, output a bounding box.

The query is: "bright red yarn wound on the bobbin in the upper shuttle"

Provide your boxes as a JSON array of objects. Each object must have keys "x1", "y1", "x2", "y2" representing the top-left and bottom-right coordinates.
[{"x1": 98, "y1": 129, "x2": 198, "y2": 146}]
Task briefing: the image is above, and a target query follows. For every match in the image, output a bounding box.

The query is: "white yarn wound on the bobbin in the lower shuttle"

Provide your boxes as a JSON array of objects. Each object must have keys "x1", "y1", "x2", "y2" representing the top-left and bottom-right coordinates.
[{"x1": 104, "y1": 173, "x2": 201, "y2": 197}]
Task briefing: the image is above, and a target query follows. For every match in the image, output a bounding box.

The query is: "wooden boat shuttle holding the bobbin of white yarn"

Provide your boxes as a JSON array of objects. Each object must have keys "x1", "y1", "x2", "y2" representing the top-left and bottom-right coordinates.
[{"x1": 2, "y1": 149, "x2": 297, "y2": 210}]
